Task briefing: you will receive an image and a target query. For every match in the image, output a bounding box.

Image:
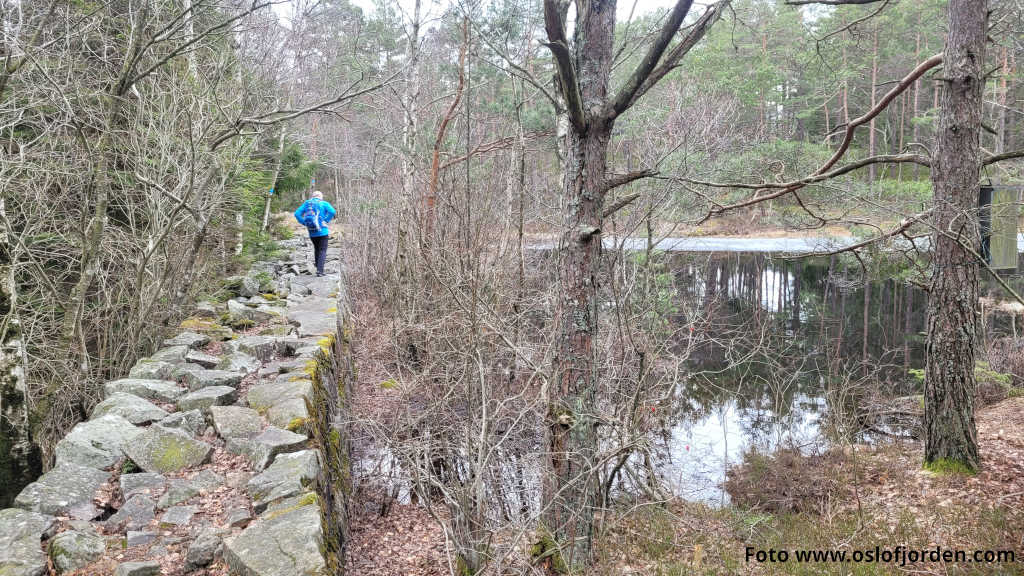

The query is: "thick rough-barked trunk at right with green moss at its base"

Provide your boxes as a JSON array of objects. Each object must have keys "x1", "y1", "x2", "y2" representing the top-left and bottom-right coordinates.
[{"x1": 925, "y1": 0, "x2": 988, "y2": 470}]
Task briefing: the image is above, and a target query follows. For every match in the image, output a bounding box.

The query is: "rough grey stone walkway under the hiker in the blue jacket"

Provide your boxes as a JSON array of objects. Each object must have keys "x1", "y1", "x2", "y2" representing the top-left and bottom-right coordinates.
[{"x1": 0, "y1": 234, "x2": 339, "y2": 576}]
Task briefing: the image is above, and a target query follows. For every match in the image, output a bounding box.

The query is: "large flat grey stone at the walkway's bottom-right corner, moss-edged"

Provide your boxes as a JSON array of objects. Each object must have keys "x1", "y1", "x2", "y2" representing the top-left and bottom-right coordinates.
[{"x1": 224, "y1": 498, "x2": 326, "y2": 576}]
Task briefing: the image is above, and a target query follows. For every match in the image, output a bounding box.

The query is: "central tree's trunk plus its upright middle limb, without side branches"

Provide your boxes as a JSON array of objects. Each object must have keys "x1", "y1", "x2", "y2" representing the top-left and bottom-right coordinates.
[{"x1": 544, "y1": 2, "x2": 615, "y2": 569}]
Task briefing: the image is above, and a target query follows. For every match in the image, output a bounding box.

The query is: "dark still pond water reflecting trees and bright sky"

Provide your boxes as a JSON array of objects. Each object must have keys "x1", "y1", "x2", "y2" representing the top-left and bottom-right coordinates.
[{"x1": 652, "y1": 245, "x2": 1024, "y2": 505}]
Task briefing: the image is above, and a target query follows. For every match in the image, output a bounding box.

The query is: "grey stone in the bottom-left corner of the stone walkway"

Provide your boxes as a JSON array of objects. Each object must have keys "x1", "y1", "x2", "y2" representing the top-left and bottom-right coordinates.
[{"x1": 0, "y1": 508, "x2": 57, "y2": 576}]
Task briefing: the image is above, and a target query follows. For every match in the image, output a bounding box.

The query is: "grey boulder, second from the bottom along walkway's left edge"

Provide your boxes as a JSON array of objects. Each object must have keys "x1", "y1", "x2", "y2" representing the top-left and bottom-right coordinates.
[{"x1": 14, "y1": 463, "x2": 111, "y2": 515}]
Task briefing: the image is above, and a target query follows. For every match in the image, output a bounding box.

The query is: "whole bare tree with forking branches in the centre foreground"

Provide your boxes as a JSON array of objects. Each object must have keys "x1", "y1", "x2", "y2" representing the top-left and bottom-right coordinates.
[{"x1": 541, "y1": 0, "x2": 728, "y2": 570}]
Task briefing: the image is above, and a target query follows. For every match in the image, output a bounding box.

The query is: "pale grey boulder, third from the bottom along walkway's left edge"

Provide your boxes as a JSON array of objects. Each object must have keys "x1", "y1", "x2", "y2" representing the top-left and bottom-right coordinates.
[{"x1": 55, "y1": 414, "x2": 142, "y2": 469}]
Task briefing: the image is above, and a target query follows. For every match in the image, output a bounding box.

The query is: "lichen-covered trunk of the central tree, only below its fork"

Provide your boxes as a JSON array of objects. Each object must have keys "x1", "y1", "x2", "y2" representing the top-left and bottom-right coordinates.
[{"x1": 545, "y1": 123, "x2": 609, "y2": 566}]
